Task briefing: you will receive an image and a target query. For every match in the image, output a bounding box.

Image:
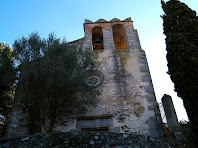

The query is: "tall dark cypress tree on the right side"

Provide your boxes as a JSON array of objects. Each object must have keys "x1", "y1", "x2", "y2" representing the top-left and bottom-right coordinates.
[{"x1": 161, "y1": 0, "x2": 198, "y2": 146}]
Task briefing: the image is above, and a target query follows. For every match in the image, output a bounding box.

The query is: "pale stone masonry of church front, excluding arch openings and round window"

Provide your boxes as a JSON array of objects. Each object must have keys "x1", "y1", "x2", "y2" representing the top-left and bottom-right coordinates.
[{"x1": 55, "y1": 18, "x2": 164, "y2": 137}]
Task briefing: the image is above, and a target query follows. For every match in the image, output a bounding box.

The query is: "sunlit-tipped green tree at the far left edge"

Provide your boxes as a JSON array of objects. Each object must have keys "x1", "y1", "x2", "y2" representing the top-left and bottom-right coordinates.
[{"x1": 0, "y1": 42, "x2": 16, "y2": 137}]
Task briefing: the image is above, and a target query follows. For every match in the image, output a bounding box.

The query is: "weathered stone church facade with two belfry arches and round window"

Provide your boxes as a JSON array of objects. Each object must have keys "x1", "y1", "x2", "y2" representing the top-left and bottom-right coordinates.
[{"x1": 7, "y1": 18, "x2": 164, "y2": 137}]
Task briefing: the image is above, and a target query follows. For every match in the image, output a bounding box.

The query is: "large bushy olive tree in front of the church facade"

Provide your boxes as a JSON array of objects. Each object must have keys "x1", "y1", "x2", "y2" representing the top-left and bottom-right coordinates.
[{"x1": 14, "y1": 33, "x2": 98, "y2": 133}]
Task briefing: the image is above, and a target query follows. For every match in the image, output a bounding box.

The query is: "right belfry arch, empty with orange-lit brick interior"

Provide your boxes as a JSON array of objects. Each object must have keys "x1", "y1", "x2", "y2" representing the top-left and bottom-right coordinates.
[{"x1": 112, "y1": 24, "x2": 127, "y2": 49}]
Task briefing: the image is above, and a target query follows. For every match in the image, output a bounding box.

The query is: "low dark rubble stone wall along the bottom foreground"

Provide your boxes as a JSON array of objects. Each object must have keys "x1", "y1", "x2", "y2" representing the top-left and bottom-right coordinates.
[{"x1": 0, "y1": 132, "x2": 178, "y2": 148}]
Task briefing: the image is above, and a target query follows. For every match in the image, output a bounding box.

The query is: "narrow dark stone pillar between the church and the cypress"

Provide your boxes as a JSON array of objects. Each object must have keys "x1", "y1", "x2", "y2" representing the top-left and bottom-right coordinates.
[{"x1": 162, "y1": 94, "x2": 179, "y2": 132}]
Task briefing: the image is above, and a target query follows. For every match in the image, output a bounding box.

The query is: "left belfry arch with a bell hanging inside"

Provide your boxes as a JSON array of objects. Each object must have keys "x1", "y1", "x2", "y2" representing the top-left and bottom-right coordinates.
[{"x1": 92, "y1": 26, "x2": 104, "y2": 50}]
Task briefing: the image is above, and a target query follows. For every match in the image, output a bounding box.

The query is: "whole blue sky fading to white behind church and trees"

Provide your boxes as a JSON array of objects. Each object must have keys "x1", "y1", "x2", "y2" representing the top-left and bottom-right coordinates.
[{"x1": 0, "y1": 0, "x2": 198, "y2": 120}]
